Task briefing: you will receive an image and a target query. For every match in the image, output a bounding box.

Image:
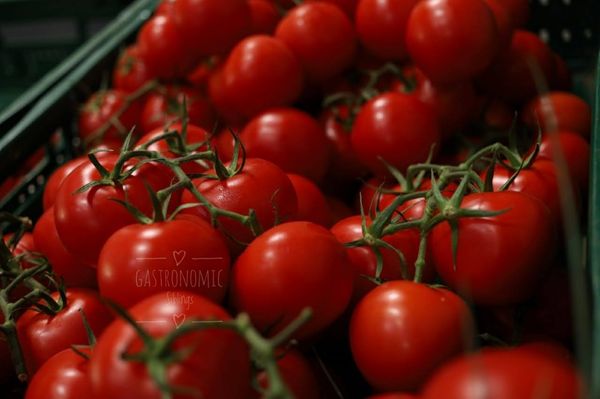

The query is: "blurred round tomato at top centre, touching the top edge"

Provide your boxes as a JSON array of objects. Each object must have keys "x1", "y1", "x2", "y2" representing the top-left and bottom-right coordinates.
[{"x1": 275, "y1": 2, "x2": 356, "y2": 82}]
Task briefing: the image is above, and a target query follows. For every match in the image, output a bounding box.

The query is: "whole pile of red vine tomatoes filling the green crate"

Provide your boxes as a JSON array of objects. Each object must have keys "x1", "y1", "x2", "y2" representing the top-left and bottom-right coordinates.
[{"x1": 0, "y1": 0, "x2": 591, "y2": 399}]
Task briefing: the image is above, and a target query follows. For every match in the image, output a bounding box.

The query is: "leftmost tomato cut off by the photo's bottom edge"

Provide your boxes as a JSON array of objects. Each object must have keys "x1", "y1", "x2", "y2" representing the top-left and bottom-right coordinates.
[{"x1": 25, "y1": 347, "x2": 94, "y2": 399}]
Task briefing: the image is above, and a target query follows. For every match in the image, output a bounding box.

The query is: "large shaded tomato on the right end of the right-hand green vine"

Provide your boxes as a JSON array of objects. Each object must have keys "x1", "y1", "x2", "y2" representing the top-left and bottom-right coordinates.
[{"x1": 429, "y1": 191, "x2": 555, "y2": 306}]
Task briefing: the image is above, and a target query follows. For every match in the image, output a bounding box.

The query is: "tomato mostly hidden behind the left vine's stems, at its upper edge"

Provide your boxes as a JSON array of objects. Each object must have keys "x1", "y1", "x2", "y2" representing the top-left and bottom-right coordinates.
[{"x1": 136, "y1": 122, "x2": 210, "y2": 175}]
